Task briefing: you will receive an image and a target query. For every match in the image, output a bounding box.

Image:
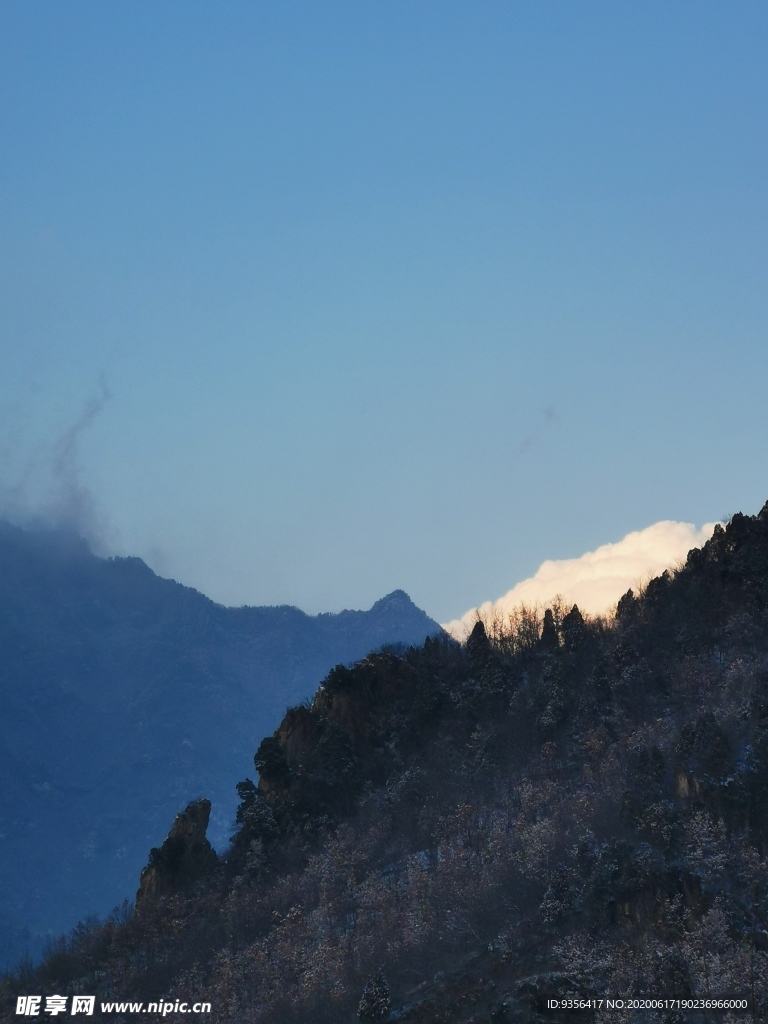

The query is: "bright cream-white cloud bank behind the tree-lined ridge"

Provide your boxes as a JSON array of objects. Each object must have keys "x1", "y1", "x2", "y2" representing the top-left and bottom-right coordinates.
[{"x1": 442, "y1": 519, "x2": 715, "y2": 640}]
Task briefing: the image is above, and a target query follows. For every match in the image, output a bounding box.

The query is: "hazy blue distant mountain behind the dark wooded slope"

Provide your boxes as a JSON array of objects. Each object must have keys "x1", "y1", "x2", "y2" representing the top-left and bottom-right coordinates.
[{"x1": 0, "y1": 522, "x2": 440, "y2": 965}]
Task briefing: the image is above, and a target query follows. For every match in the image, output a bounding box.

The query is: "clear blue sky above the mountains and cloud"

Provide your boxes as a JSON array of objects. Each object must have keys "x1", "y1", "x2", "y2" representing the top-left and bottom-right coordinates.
[{"x1": 0, "y1": 0, "x2": 768, "y2": 620}]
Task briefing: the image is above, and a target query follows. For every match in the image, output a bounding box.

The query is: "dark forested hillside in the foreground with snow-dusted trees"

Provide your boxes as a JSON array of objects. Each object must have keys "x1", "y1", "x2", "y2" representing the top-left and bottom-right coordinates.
[{"x1": 4, "y1": 505, "x2": 768, "y2": 1024}]
